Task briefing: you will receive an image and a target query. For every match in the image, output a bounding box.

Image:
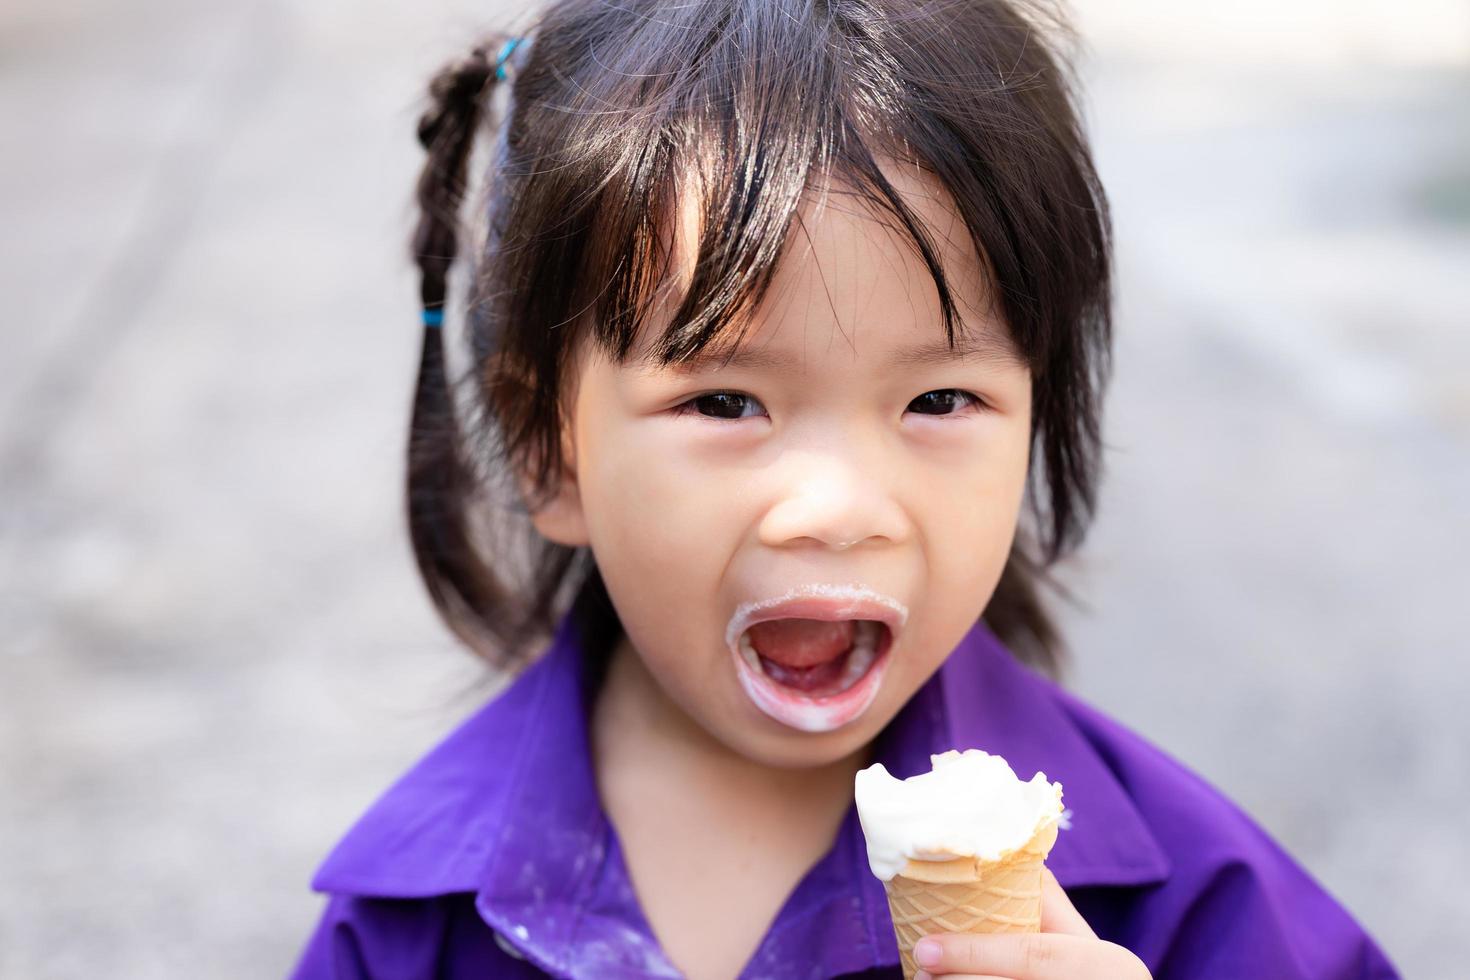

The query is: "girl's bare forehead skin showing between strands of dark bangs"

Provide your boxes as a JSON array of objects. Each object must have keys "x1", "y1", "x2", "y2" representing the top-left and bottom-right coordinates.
[{"x1": 634, "y1": 157, "x2": 1025, "y2": 372}]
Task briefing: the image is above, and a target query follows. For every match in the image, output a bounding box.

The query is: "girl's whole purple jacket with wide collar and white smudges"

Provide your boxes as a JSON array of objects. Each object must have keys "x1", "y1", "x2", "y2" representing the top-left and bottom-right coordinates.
[{"x1": 293, "y1": 617, "x2": 1398, "y2": 980}]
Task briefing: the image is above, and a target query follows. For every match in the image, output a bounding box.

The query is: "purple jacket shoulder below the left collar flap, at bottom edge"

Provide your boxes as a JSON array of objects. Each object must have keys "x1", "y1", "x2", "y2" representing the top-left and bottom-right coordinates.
[{"x1": 290, "y1": 895, "x2": 545, "y2": 980}]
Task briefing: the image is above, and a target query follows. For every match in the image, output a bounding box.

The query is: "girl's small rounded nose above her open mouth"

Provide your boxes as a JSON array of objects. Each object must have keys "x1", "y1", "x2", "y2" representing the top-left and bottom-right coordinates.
[{"x1": 760, "y1": 454, "x2": 910, "y2": 551}]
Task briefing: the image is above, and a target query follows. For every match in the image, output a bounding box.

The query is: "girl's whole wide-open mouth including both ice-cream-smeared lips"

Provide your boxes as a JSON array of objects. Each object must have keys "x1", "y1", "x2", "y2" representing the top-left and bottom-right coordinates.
[{"x1": 725, "y1": 585, "x2": 908, "y2": 732}]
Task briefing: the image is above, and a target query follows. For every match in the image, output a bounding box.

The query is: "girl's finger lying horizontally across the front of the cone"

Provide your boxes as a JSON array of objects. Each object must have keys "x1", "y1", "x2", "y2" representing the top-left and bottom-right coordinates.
[{"x1": 914, "y1": 933, "x2": 1100, "y2": 980}]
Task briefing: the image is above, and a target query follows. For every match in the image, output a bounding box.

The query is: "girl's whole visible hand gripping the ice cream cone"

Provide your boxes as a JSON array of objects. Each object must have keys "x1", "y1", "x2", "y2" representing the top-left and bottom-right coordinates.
[{"x1": 914, "y1": 868, "x2": 1150, "y2": 980}]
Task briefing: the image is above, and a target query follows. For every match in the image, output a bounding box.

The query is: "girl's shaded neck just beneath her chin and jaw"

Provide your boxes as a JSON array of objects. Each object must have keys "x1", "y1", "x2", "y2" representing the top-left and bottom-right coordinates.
[{"x1": 591, "y1": 635, "x2": 870, "y2": 830}]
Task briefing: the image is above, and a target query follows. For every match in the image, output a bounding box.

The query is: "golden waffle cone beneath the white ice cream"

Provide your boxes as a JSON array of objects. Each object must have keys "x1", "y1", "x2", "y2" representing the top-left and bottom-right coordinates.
[{"x1": 883, "y1": 820, "x2": 1057, "y2": 980}]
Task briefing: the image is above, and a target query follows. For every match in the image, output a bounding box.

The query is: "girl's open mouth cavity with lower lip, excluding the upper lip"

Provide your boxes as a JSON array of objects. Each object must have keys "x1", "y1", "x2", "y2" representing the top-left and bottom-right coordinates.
[{"x1": 734, "y1": 619, "x2": 894, "y2": 732}]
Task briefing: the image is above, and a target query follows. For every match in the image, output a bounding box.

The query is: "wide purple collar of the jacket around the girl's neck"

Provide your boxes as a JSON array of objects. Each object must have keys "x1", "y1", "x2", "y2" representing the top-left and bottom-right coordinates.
[{"x1": 312, "y1": 616, "x2": 1169, "y2": 976}]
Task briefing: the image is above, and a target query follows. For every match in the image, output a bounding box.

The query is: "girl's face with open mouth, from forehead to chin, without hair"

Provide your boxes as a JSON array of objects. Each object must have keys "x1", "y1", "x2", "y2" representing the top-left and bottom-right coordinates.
[{"x1": 535, "y1": 166, "x2": 1032, "y2": 767}]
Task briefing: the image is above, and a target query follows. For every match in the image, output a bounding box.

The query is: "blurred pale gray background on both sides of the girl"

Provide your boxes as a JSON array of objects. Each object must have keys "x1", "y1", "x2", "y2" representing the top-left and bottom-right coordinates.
[{"x1": 0, "y1": 0, "x2": 1470, "y2": 979}]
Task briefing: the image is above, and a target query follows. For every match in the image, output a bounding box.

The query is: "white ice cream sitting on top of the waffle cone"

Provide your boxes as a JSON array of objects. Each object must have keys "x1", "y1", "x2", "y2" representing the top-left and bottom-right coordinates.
[{"x1": 854, "y1": 749, "x2": 1061, "y2": 882}]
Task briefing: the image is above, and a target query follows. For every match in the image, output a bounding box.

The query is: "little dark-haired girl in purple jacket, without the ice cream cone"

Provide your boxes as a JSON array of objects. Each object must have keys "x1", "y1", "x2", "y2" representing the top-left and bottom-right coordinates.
[{"x1": 295, "y1": 0, "x2": 1395, "y2": 980}]
